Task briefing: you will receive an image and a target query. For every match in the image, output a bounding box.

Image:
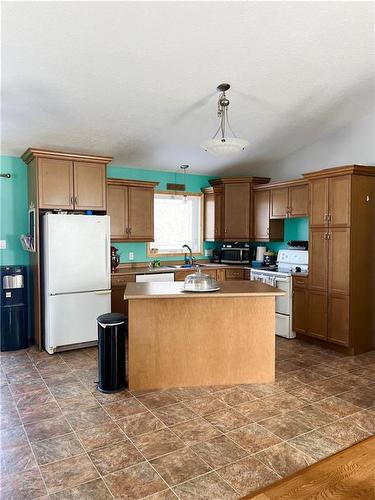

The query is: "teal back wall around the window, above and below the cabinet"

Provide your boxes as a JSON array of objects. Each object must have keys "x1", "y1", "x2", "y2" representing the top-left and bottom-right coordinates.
[{"x1": 107, "y1": 166, "x2": 219, "y2": 263}]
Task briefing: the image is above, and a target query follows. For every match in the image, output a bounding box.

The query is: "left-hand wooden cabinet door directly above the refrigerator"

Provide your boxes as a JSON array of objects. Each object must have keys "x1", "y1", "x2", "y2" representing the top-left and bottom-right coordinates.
[{"x1": 38, "y1": 158, "x2": 74, "y2": 210}]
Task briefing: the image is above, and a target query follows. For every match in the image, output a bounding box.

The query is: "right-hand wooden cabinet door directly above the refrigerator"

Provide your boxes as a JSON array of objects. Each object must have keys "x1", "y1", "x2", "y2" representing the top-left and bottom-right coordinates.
[{"x1": 74, "y1": 161, "x2": 107, "y2": 210}]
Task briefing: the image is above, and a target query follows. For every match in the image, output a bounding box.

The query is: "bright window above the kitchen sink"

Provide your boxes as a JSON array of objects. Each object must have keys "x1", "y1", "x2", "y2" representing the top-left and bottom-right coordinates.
[{"x1": 148, "y1": 193, "x2": 203, "y2": 257}]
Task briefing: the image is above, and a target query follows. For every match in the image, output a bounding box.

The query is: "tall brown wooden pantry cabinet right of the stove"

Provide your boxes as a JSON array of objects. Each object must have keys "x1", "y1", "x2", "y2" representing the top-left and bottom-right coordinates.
[{"x1": 304, "y1": 165, "x2": 375, "y2": 354}]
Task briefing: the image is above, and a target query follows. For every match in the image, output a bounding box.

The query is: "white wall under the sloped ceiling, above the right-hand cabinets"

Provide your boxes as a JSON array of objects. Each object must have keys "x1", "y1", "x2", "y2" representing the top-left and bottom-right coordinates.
[{"x1": 258, "y1": 113, "x2": 375, "y2": 181}]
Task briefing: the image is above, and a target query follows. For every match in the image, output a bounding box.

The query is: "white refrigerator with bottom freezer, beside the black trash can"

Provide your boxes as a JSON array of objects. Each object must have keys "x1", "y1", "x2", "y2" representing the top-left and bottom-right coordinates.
[{"x1": 42, "y1": 214, "x2": 111, "y2": 354}]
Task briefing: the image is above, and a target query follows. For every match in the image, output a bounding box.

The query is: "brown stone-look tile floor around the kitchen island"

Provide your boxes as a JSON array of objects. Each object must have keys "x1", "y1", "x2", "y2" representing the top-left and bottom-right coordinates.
[{"x1": 0, "y1": 338, "x2": 375, "y2": 500}]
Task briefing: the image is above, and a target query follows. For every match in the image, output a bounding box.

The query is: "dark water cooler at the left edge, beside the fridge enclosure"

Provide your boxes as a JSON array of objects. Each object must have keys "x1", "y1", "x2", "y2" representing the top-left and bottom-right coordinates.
[{"x1": 0, "y1": 266, "x2": 28, "y2": 351}]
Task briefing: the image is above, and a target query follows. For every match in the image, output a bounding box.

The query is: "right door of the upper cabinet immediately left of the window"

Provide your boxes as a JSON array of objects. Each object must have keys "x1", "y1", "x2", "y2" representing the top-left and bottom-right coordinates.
[{"x1": 128, "y1": 186, "x2": 154, "y2": 241}]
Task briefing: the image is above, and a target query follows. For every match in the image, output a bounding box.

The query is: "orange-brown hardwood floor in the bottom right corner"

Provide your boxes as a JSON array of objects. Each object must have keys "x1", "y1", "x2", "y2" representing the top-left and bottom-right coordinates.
[{"x1": 244, "y1": 437, "x2": 375, "y2": 500}]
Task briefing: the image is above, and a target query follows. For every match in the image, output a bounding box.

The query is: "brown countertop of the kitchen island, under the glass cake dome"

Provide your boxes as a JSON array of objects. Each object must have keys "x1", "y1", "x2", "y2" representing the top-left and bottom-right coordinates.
[{"x1": 124, "y1": 281, "x2": 285, "y2": 300}]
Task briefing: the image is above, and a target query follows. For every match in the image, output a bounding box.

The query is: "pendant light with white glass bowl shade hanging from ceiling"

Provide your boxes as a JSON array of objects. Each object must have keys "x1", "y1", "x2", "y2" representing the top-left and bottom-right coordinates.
[{"x1": 201, "y1": 83, "x2": 249, "y2": 156}]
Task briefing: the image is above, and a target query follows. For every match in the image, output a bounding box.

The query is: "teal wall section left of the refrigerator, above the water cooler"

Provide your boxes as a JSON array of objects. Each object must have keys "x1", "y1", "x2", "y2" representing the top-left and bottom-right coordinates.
[{"x1": 0, "y1": 156, "x2": 29, "y2": 266}]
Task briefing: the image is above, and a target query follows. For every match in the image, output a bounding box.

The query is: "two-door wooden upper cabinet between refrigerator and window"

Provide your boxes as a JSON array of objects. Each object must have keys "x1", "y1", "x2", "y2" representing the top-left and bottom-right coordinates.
[{"x1": 107, "y1": 179, "x2": 158, "y2": 241}]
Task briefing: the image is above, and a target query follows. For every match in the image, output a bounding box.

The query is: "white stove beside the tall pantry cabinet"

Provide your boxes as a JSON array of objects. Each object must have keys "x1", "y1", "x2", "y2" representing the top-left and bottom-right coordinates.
[{"x1": 250, "y1": 249, "x2": 308, "y2": 339}]
